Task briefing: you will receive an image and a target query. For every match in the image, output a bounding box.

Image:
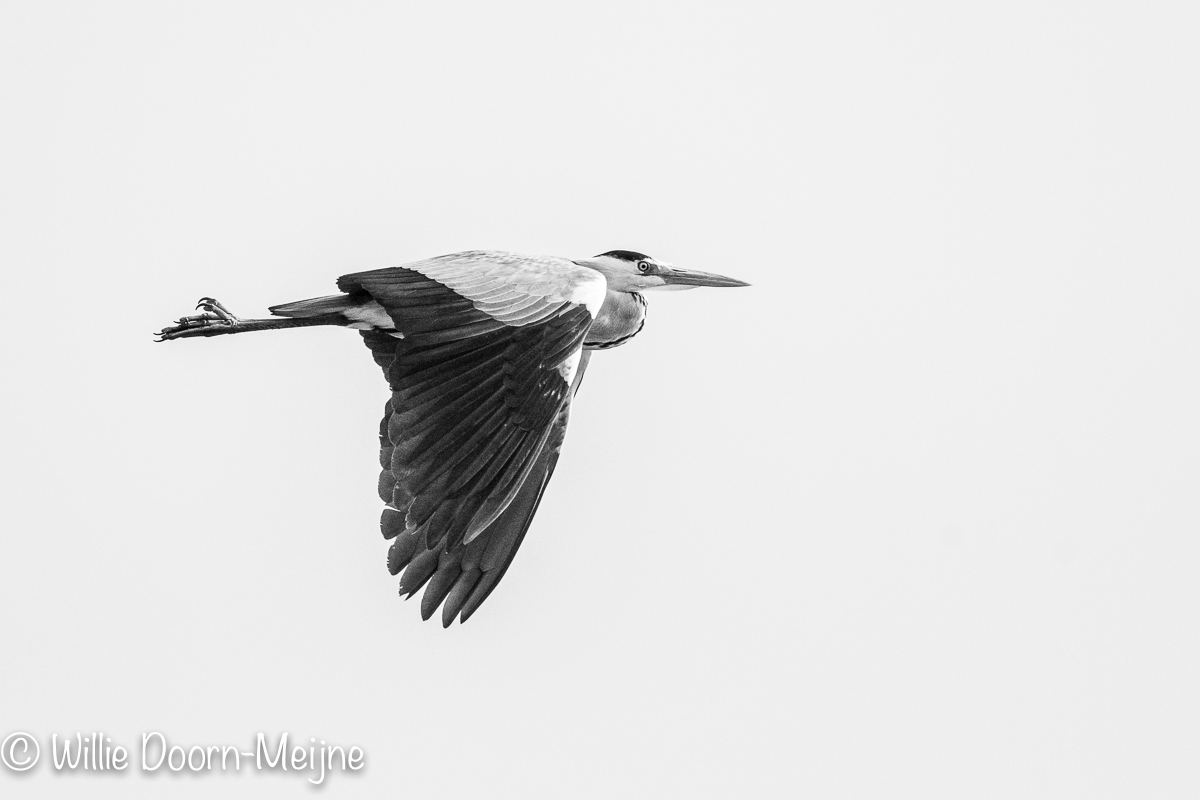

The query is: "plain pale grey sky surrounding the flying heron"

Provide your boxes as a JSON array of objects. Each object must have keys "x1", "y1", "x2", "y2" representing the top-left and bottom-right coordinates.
[{"x1": 0, "y1": 0, "x2": 1200, "y2": 800}]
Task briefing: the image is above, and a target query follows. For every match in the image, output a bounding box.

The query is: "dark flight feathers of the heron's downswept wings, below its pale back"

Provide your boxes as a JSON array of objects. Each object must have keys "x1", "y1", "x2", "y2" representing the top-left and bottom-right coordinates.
[{"x1": 338, "y1": 257, "x2": 604, "y2": 625}]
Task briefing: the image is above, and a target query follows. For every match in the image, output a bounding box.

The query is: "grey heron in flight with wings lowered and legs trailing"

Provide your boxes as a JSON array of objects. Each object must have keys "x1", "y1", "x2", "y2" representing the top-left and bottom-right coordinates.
[{"x1": 157, "y1": 249, "x2": 749, "y2": 627}]
